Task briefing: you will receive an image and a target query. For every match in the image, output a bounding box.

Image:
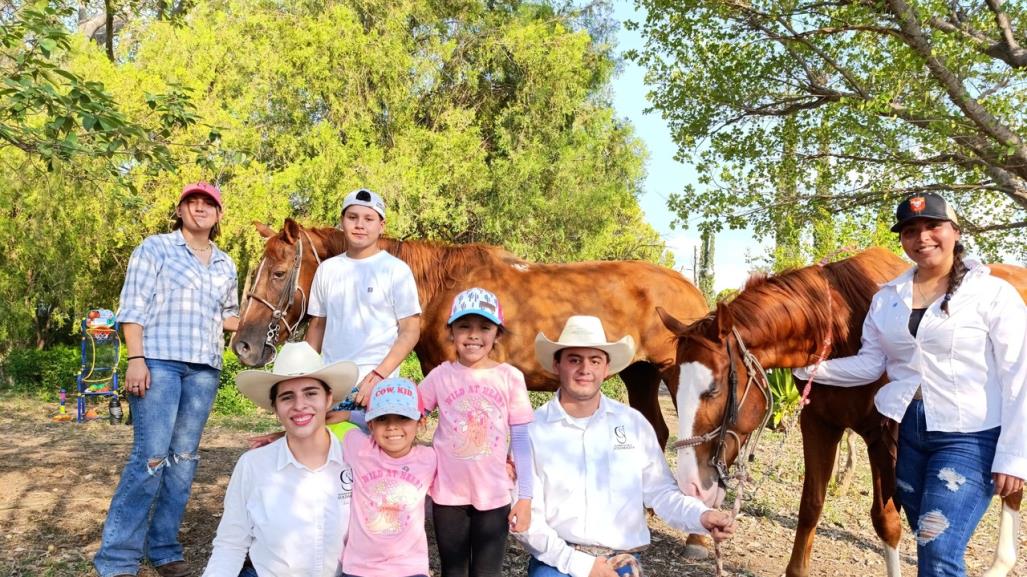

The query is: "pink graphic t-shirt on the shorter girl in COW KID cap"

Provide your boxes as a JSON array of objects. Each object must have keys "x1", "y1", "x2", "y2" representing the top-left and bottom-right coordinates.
[{"x1": 342, "y1": 431, "x2": 435, "y2": 577}]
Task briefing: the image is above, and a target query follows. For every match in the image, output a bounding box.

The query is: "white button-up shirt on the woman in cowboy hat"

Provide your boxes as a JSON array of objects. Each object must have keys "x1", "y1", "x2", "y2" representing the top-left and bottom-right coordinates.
[{"x1": 203, "y1": 435, "x2": 353, "y2": 577}]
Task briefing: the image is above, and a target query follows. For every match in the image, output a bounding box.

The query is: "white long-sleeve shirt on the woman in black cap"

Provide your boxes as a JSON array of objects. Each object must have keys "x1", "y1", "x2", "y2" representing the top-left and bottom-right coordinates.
[{"x1": 794, "y1": 261, "x2": 1027, "y2": 478}]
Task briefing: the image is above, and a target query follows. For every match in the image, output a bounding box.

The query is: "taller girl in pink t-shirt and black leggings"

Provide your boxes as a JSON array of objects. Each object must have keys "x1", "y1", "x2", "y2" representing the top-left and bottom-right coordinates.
[{"x1": 419, "y1": 289, "x2": 534, "y2": 577}]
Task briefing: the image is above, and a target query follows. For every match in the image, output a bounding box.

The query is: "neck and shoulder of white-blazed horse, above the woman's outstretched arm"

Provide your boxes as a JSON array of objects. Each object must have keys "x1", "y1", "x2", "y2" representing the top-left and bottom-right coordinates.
[{"x1": 705, "y1": 247, "x2": 899, "y2": 356}]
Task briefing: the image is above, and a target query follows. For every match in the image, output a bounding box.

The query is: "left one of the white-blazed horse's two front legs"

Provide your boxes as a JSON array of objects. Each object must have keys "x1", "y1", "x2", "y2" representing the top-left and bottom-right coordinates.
[{"x1": 785, "y1": 406, "x2": 845, "y2": 577}]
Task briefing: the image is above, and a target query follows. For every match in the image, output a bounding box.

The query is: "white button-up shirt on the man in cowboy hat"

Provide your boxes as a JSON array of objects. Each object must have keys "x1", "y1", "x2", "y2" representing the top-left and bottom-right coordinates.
[{"x1": 514, "y1": 390, "x2": 708, "y2": 577}]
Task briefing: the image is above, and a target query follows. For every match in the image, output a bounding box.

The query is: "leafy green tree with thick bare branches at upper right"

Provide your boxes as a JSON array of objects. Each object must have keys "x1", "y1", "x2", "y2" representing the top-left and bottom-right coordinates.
[{"x1": 635, "y1": 0, "x2": 1027, "y2": 255}]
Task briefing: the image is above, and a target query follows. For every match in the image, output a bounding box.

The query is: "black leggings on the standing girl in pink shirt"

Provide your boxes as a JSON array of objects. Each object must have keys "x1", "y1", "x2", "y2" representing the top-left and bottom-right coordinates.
[{"x1": 431, "y1": 504, "x2": 510, "y2": 577}]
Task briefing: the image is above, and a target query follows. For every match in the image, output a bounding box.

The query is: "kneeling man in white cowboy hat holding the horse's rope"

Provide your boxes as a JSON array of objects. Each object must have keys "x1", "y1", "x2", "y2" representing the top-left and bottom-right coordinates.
[{"x1": 515, "y1": 316, "x2": 734, "y2": 577}]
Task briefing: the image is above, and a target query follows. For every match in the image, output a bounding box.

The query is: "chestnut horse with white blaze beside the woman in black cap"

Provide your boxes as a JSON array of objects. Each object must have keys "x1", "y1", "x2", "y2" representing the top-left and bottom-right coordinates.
[{"x1": 660, "y1": 248, "x2": 1027, "y2": 577}]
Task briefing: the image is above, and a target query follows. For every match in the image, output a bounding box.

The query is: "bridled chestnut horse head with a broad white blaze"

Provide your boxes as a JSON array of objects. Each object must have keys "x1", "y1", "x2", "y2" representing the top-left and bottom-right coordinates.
[{"x1": 657, "y1": 303, "x2": 770, "y2": 506}]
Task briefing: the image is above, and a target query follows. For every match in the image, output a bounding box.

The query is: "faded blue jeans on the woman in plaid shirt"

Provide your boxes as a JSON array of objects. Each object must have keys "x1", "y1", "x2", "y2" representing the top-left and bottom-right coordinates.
[{"x1": 92, "y1": 358, "x2": 220, "y2": 577}]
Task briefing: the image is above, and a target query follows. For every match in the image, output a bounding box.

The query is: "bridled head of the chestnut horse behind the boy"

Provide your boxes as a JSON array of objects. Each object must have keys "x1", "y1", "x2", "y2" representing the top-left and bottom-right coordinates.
[{"x1": 232, "y1": 219, "x2": 331, "y2": 367}]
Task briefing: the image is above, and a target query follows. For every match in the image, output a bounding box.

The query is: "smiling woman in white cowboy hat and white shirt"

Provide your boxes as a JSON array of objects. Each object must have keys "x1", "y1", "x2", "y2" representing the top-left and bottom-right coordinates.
[{"x1": 203, "y1": 342, "x2": 357, "y2": 577}]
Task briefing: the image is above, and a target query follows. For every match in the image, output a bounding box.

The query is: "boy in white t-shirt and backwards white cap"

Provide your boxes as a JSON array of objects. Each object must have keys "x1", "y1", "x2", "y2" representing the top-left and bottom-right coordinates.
[{"x1": 306, "y1": 189, "x2": 421, "y2": 406}]
